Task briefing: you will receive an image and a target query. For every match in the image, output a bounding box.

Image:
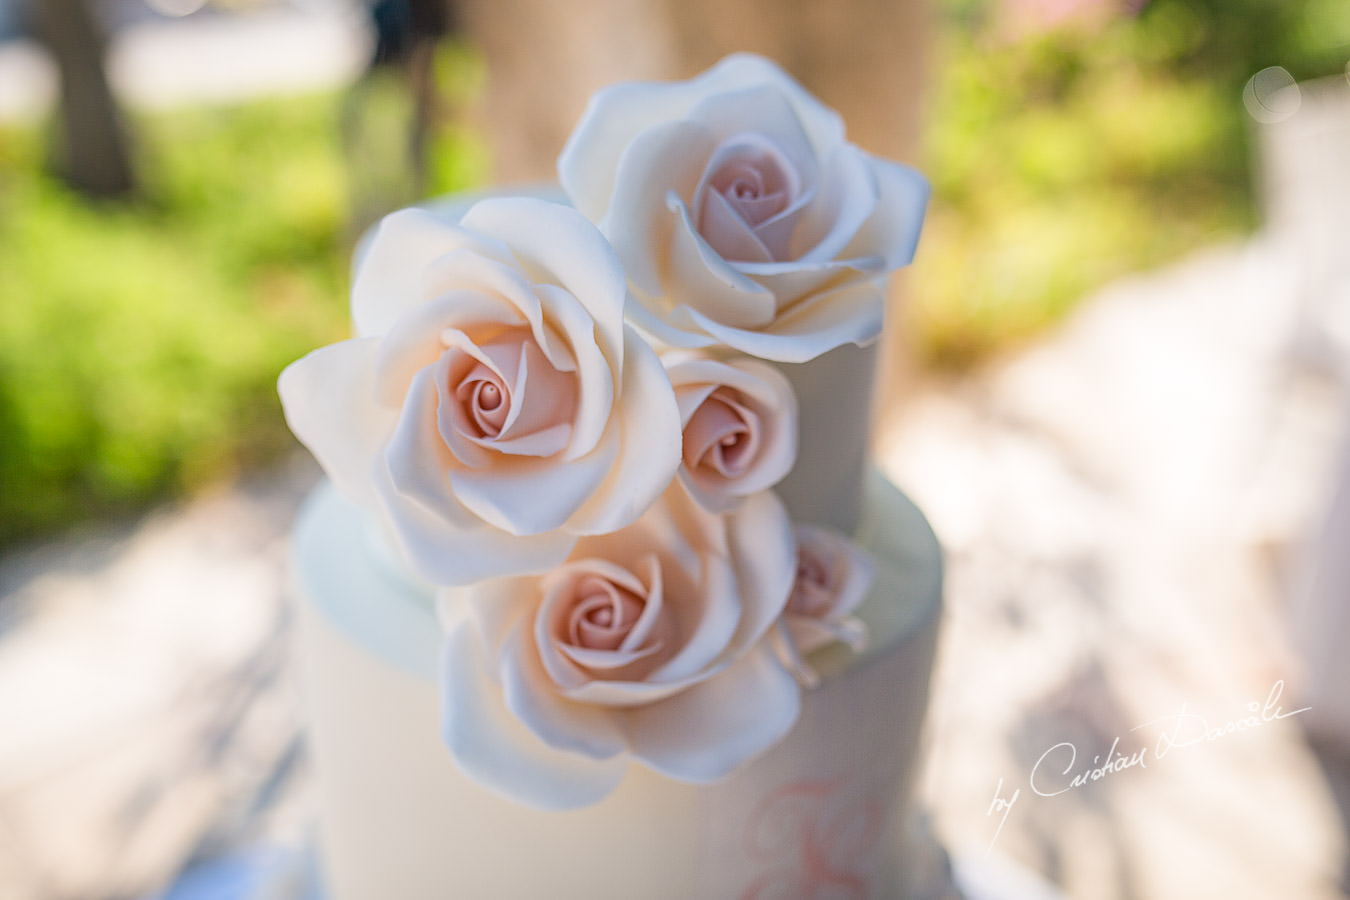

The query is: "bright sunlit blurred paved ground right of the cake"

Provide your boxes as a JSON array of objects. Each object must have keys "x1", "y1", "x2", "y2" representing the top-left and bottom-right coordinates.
[{"x1": 886, "y1": 234, "x2": 1350, "y2": 900}]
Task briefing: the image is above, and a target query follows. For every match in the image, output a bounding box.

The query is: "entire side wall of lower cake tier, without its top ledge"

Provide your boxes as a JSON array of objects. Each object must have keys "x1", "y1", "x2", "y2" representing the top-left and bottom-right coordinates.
[{"x1": 300, "y1": 569, "x2": 936, "y2": 900}]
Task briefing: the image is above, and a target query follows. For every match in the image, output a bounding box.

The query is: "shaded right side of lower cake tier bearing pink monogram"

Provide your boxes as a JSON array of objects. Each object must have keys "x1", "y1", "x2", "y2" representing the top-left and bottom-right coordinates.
[{"x1": 698, "y1": 593, "x2": 937, "y2": 900}]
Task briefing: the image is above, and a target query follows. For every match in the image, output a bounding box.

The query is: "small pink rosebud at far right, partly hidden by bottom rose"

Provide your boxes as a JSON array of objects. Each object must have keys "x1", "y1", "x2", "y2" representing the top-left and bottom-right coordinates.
[{"x1": 775, "y1": 525, "x2": 876, "y2": 687}]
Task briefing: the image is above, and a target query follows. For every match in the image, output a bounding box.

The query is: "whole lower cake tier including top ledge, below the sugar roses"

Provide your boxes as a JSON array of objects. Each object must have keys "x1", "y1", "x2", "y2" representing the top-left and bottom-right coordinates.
[{"x1": 294, "y1": 474, "x2": 942, "y2": 900}]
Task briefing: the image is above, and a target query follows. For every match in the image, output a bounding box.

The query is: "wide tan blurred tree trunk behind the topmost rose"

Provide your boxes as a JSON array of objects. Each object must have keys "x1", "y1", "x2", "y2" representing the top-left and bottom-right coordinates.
[{"x1": 456, "y1": 0, "x2": 930, "y2": 182}]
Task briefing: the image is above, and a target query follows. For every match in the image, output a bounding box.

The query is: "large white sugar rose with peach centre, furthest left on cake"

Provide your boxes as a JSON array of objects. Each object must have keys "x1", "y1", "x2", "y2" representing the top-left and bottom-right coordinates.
[{"x1": 278, "y1": 197, "x2": 680, "y2": 584}]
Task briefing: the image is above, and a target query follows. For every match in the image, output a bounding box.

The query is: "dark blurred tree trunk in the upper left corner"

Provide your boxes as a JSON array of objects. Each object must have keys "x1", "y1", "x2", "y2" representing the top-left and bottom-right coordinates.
[{"x1": 28, "y1": 0, "x2": 136, "y2": 197}]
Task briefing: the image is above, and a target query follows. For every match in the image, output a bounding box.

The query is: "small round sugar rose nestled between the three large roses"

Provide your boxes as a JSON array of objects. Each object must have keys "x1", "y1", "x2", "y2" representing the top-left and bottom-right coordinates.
[{"x1": 662, "y1": 351, "x2": 797, "y2": 513}]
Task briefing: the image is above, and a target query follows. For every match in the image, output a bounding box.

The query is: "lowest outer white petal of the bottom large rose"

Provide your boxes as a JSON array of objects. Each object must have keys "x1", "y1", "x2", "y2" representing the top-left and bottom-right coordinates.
[{"x1": 440, "y1": 622, "x2": 628, "y2": 810}]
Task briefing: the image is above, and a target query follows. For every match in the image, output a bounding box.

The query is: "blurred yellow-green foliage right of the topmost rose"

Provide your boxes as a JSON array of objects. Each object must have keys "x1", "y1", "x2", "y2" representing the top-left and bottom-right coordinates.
[{"x1": 910, "y1": 0, "x2": 1350, "y2": 368}]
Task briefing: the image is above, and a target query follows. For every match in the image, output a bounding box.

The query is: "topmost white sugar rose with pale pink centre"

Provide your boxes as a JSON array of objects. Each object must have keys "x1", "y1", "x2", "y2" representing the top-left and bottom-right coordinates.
[{"x1": 558, "y1": 54, "x2": 927, "y2": 362}]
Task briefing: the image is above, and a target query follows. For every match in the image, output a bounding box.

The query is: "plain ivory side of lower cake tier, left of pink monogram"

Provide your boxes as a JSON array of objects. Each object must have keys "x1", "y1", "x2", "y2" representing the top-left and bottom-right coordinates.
[{"x1": 301, "y1": 591, "x2": 701, "y2": 900}]
